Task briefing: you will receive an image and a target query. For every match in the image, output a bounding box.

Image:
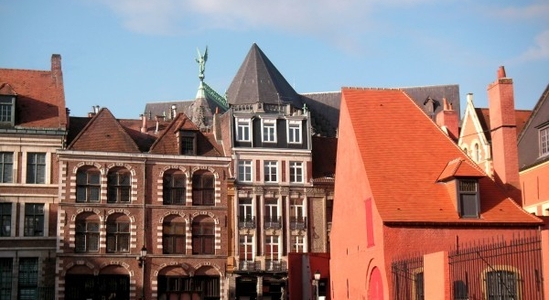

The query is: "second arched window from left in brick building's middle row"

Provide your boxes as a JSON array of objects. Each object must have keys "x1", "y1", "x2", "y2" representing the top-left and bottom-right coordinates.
[{"x1": 107, "y1": 214, "x2": 130, "y2": 253}]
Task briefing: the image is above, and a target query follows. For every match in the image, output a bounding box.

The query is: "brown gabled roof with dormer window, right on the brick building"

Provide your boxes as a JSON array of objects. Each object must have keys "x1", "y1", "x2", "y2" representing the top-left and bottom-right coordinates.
[{"x1": 149, "y1": 113, "x2": 222, "y2": 156}]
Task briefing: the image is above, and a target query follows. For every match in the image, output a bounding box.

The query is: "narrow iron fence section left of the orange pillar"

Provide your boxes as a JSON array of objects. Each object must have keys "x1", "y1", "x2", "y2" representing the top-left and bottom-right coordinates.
[{"x1": 391, "y1": 255, "x2": 425, "y2": 300}]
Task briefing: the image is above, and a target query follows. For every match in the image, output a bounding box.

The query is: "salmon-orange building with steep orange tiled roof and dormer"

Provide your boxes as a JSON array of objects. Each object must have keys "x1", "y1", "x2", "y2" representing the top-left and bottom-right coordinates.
[{"x1": 329, "y1": 86, "x2": 543, "y2": 300}]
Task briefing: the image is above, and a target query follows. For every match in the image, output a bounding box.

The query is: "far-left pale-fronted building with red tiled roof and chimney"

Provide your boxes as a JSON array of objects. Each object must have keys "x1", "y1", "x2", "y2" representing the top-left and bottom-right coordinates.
[{"x1": 0, "y1": 54, "x2": 67, "y2": 300}]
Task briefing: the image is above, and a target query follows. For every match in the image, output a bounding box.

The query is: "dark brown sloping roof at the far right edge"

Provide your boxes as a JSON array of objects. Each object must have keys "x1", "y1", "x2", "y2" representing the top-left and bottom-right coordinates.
[{"x1": 518, "y1": 84, "x2": 549, "y2": 171}]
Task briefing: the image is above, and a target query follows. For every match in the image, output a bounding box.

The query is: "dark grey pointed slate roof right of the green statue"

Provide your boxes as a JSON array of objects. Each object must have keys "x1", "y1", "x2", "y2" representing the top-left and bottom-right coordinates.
[{"x1": 227, "y1": 43, "x2": 302, "y2": 108}]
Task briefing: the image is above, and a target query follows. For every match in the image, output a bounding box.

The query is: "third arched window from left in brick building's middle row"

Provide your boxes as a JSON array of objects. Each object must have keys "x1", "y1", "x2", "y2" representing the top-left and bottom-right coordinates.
[{"x1": 162, "y1": 216, "x2": 185, "y2": 254}]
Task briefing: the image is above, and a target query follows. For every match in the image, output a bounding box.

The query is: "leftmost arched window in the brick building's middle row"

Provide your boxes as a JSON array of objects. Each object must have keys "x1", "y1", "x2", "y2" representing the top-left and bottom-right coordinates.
[{"x1": 74, "y1": 213, "x2": 99, "y2": 252}]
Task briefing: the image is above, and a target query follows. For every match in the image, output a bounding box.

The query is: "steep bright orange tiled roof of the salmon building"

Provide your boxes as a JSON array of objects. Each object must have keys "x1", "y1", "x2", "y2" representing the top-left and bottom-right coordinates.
[{"x1": 336, "y1": 88, "x2": 540, "y2": 225}]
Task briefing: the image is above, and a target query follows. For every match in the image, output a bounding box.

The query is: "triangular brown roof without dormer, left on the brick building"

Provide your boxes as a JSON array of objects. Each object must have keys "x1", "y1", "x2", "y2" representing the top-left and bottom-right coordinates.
[{"x1": 67, "y1": 108, "x2": 141, "y2": 153}]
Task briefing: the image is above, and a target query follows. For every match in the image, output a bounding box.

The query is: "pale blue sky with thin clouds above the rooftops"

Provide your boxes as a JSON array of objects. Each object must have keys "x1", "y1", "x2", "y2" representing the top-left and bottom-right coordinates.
[{"x1": 0, "y1": 0, "x2": 549, "y2": 118}]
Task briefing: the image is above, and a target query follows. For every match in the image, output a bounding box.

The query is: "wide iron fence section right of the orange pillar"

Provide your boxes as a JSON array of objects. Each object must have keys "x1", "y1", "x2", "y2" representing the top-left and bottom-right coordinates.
[{"x1": 448, "y1": 231, "x2": 544, "y2": 300}]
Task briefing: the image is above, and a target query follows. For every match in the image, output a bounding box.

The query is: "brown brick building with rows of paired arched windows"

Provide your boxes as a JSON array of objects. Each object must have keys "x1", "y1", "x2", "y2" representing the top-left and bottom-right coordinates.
[{"x1": 56, "y1": 108, "x2": 230, "y2": 300}]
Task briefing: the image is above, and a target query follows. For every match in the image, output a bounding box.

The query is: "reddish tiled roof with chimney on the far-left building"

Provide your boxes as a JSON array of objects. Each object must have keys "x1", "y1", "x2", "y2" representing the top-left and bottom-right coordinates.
[{"x1": 0, "y1": 54, "x2": 67, "y2": 130}]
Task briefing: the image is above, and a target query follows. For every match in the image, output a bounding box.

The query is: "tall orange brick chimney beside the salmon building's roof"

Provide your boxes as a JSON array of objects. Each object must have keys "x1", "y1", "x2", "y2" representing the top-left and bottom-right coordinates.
[{"x1": 488, "y1": 66, "x2": 522, "y2": 206}]
